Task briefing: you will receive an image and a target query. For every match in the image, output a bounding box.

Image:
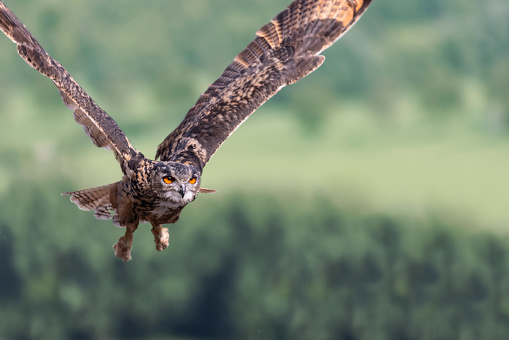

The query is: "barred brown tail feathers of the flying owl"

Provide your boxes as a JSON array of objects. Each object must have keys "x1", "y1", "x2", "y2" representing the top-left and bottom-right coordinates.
[{"x1": 62, "y1": 183, "x2": 117, "y2": 220}]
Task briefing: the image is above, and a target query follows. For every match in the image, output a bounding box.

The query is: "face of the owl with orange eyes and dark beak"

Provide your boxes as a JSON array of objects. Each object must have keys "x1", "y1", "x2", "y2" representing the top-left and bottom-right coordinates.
[{"x1": 152, "y1": 162, "x2": 200, "y2": 205}]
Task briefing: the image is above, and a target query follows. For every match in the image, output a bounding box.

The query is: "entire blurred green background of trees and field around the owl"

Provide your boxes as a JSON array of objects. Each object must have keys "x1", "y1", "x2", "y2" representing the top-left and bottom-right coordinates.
[{"x1": 0, "y1": 0, "x2": 509, "y2": 340}]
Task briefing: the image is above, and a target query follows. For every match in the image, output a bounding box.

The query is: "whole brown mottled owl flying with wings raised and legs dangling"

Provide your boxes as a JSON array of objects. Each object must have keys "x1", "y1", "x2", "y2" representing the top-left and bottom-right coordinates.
[{"x1": 0, "y1": 0, "x2": 371, "y2": 261}]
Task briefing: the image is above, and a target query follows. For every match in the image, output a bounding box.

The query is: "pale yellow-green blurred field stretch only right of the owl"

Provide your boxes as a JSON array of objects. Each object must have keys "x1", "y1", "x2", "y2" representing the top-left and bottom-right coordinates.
[{"x1": 205, "y1": 105, "x2": 509, "y2": 231}]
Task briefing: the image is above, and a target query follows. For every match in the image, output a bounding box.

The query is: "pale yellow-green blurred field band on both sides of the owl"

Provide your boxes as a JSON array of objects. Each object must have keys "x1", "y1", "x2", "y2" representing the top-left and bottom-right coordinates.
[{"x1": 0, "y1": 100, "x2": 509, "y2": 228}]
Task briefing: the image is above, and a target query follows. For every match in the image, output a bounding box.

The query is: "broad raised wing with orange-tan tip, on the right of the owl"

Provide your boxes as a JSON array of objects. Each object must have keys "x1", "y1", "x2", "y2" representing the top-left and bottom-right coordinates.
[{"x1": 156, "y1": 0, "x2": 371, "y2": 169}]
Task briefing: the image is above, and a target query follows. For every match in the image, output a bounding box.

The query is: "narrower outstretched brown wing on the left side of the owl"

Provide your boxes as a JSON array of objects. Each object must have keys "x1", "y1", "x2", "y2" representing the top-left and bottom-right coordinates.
[{"x1": 0, "y1": 1, "x2": 138, "y2": 173}]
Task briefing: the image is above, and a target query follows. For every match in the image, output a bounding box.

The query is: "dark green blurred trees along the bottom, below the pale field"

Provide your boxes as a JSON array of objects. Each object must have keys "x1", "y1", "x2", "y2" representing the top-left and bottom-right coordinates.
[{"x1": 0, "y1": 183, "x2": 509, "y2": 339}]
